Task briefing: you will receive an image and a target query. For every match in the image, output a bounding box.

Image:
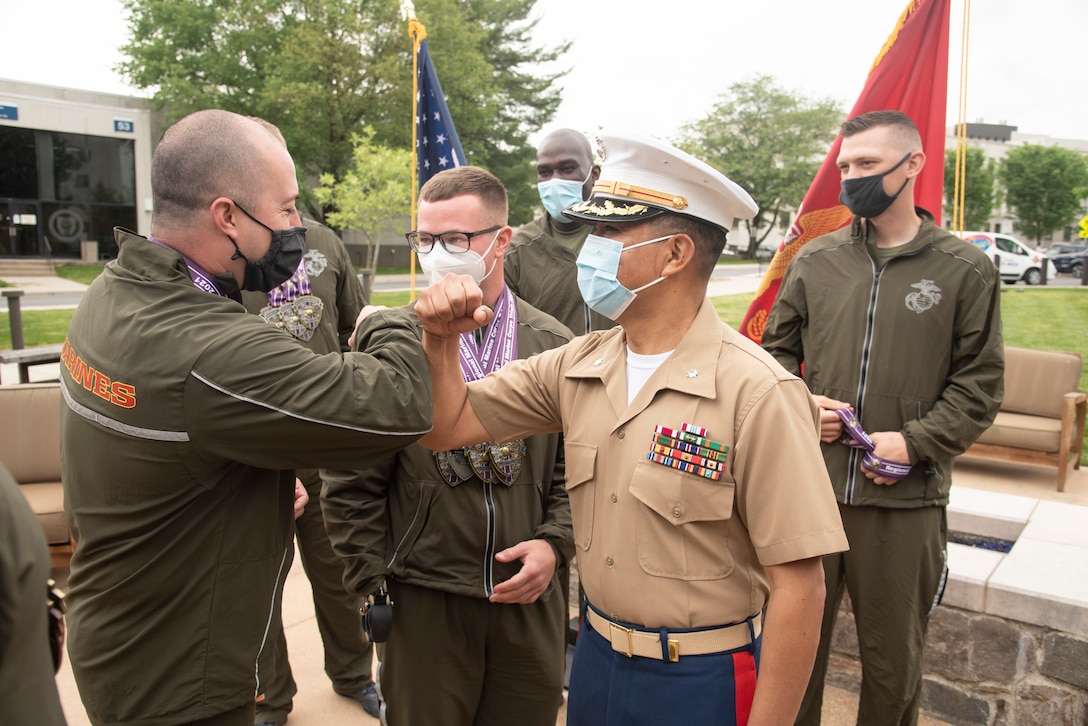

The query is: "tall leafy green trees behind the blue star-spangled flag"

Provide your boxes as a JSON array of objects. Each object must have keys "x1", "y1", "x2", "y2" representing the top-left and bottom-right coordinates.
[{"x1": 119, "y1": 0, "x2": 569, "y2": 219}]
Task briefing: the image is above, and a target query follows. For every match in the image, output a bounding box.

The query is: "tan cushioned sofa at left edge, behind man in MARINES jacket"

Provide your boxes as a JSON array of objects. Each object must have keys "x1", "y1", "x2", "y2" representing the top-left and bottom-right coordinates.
[{"x1": 0, "y1": 383, "x2": 74, "y2": 567}]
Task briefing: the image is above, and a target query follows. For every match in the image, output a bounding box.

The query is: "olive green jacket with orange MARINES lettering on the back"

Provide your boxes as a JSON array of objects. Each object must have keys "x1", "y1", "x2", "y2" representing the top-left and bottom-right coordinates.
[{"x1": 61, "y1": 230, "x2": 431, "y2": 724}]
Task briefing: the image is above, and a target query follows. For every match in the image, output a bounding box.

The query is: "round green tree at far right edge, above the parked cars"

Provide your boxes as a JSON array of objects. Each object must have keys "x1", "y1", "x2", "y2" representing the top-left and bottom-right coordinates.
[{"x1": 998, "y1": 144, "x2": 1088, "y2": 245}]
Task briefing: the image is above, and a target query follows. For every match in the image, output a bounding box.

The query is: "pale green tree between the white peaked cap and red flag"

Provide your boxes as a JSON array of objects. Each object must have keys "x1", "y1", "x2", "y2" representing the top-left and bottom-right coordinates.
[{"x1": 678, "y1": 75, "x2": 843, "y2": 256}]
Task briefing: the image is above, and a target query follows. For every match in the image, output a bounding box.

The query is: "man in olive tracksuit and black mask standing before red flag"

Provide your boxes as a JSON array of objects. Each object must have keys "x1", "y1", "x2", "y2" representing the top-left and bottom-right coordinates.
[{"x1": 763, "y1": 111, "x2": 1004, "y2": 726}]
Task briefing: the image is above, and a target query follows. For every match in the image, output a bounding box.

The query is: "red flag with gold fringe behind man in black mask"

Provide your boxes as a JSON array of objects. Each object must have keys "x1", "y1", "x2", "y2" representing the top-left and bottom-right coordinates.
[{"x1": 741, "y1": 0, "x2": 951, "y2": 343}]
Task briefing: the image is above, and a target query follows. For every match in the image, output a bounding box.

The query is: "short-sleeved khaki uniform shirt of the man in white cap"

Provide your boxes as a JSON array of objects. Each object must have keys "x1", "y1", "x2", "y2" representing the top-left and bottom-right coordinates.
[{"x1": 469, "y1": 300, "x2": 848, "y2": 628}]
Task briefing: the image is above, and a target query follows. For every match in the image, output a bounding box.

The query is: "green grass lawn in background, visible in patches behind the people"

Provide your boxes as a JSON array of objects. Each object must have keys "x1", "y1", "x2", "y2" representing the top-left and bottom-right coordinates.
[{"x1": 0, "y1": 282, "x2": 1088, "y2": 464}]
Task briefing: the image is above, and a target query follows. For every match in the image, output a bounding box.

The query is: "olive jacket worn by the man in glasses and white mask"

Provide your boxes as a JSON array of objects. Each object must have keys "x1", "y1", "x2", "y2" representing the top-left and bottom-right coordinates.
[{"x1": 321, "y1": 300, "x2": 574, "y2": 598}]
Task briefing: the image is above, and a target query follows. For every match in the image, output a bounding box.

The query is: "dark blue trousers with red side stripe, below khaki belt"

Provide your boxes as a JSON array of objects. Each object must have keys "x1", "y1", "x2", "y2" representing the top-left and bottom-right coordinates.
[{"x1": 567, "y1": 618, "x2": 762, "y2": 726}]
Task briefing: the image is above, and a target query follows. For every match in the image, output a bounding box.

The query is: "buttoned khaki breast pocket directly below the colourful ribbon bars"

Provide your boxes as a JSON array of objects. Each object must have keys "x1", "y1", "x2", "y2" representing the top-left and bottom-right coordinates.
[{"x1": 631, "y1": 460, "x2": 735, "y2": 580}]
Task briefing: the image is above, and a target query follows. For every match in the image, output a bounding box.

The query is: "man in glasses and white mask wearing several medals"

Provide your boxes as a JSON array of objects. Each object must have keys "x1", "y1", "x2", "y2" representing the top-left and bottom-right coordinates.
[{"x1": 322, "y1": 167, "x2": 574, "y2": 726}]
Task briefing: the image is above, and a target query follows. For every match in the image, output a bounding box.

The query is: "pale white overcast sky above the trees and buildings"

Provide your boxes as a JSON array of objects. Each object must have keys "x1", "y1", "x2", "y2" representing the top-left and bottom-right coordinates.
[{"x1": 8, "y1": 0, "x2": 1088, "y2": 139}]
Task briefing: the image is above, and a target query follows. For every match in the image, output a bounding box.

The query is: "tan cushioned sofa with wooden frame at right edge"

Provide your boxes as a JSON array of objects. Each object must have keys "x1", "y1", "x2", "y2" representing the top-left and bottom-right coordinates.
[{"x1": 964, "y1": 346, "x2": 1088, "y2": 492}]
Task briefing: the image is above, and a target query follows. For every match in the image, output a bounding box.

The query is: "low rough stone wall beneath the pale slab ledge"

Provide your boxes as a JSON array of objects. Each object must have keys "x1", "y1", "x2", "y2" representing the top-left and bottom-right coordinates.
[{"x1": 828, "y1": 596, "x2": 1088, "y2": 726}]
